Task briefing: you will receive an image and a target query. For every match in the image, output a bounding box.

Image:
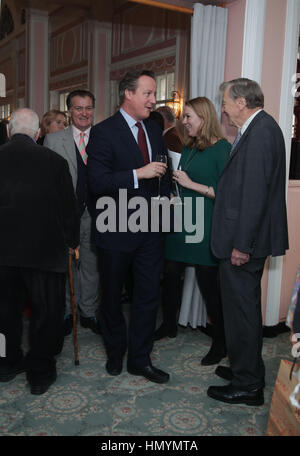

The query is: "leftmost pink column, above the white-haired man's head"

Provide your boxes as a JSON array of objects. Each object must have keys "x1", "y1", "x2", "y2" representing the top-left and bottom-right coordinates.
[{"x1": 25, "y1": 8, "x2": 49, "y2": 118}]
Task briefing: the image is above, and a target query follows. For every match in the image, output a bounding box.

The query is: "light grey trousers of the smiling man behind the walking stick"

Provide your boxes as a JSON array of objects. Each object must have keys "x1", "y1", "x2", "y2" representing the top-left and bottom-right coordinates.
[{"x1": 65, "y1": 209, "x2": 99, "y2": 317}]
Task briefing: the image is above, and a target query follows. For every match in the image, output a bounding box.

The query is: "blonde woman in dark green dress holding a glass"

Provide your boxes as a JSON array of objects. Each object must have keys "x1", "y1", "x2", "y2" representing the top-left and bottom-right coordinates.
[{"x1": 155, "y1": 97, "x2": 231, "y2": 365}]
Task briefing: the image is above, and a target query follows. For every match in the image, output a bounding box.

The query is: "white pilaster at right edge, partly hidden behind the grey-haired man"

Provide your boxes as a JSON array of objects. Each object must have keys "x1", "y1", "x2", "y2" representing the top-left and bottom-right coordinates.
[{"x1": 265, "y1": 0, "x2": 300, "y2": 326}]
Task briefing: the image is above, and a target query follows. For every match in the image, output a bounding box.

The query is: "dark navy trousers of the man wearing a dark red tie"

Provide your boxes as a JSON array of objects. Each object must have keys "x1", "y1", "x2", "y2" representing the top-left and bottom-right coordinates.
[{"x1": 99, "y1": 233, "x2": 162, "y2": 366}]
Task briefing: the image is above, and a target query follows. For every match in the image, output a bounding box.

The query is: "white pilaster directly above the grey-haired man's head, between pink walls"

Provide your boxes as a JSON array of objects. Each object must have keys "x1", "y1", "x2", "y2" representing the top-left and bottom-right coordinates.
[{"x1": 242, "y1": 0, "x2": 266, "y2": 83}]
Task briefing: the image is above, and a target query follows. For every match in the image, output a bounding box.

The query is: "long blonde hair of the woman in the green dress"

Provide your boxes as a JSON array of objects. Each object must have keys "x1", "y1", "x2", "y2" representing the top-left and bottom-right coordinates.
[{"x1": 184, "y1": 97, "x2": 224, "y2": 149}]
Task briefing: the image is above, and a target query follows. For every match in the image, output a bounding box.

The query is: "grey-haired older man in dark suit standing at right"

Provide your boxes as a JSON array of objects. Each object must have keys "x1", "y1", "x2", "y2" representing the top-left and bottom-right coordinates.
[{"x1": 208, "y1": 78, "x2": 288, "y2": 405}]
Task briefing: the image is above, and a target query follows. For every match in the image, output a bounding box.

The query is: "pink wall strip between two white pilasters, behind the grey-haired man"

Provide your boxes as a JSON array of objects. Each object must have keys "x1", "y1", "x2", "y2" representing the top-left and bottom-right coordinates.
[{"x1": 261, "y1": 0, "x2": 288, "y2": 121}]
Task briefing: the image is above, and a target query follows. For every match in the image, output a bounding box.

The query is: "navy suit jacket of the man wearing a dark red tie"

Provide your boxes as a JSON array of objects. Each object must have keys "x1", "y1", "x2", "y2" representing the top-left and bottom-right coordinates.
[{"x1": 87, "y1": 112, "x2": 170, "y2": 251}]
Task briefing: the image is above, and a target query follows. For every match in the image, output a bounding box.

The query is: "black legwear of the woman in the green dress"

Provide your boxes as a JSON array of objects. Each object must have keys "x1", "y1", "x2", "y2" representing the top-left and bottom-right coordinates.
[{"x1": 162, "y1": 260, "x2": 224, "y2": 344}]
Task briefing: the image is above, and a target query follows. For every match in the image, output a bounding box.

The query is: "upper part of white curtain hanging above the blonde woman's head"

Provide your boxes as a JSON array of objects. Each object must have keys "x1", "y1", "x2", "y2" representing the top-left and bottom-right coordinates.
[{"x1": 190, "y1": 3, "x2": 228, "y2": 114}]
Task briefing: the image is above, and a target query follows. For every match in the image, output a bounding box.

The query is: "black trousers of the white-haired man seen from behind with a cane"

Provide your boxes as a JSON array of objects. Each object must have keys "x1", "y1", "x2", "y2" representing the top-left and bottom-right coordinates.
[{"x1": 0, "y1": 266, "x2": 66, "y2": 377}]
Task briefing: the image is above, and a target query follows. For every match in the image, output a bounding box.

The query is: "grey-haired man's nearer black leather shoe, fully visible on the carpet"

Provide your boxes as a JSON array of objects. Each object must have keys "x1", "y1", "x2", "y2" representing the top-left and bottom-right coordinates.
[{"x1": 207, "y1": 383, "x2": 264, "y2": 406}]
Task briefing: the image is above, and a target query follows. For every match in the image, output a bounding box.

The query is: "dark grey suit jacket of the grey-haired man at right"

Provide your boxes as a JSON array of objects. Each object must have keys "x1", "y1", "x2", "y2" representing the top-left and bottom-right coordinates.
[{"x1": 211, "y1": 111, "x2": 288, "y2": 259}]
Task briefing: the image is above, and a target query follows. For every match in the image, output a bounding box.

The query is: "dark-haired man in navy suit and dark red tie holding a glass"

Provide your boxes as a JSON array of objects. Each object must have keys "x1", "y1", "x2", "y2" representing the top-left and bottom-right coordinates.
[{"x1": 87, "y1": 71, "x2": 170, "y2": 383}]
